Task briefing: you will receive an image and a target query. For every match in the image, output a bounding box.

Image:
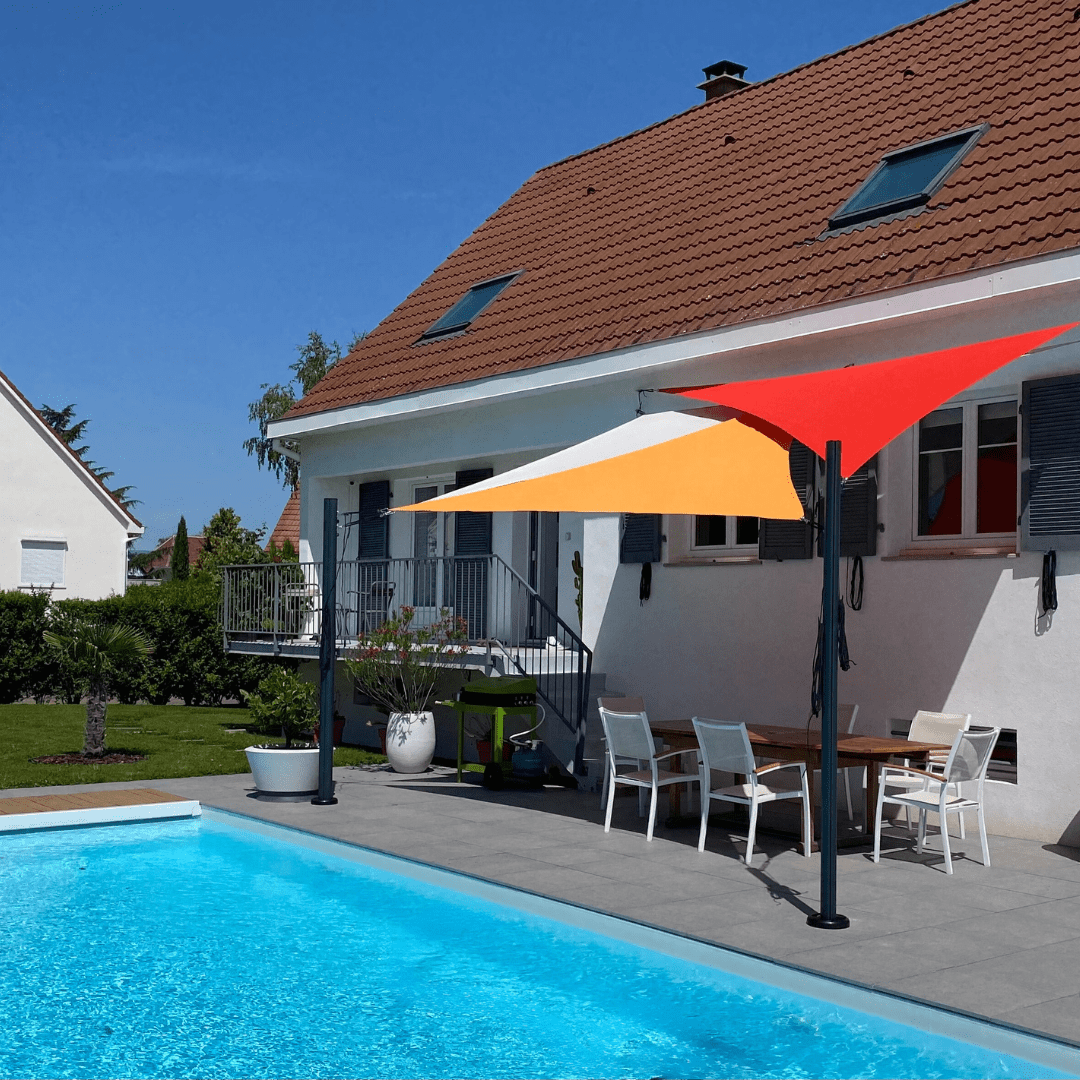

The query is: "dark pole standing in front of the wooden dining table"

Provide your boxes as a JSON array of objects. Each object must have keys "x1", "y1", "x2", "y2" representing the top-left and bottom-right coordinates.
[{"x1": 807, "y1": 440, "x2": 851, "y2": 930}]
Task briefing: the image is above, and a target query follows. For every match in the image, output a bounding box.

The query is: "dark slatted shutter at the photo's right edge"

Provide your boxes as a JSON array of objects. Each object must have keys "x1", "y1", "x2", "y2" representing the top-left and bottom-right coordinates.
[{"x1": 1021, "y1": 375, "x2": 1080, "y2": 551}]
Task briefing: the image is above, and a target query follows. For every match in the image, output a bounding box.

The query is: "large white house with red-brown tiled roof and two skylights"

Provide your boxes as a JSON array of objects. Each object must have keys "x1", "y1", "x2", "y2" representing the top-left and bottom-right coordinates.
[{"x1": 254, "y1": 0, "x2": 1080, "y2": 845}]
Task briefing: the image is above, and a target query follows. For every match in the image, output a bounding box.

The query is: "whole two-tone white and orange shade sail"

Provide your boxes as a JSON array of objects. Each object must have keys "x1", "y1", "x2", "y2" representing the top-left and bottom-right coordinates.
[{"x1": 395, "y1": 413, "x2": 804, "y2": 521}]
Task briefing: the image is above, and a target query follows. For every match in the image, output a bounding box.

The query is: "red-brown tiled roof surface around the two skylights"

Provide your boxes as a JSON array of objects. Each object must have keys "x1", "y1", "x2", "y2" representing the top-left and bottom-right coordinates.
[{"x1": 288, "y1": 0, "x2": 1080, "y2": 417}]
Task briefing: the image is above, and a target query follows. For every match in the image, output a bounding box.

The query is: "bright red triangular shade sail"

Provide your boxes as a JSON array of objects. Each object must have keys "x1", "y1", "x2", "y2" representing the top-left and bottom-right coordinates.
[{"x1": 674, "y1": 323, "x2": 1080, "y2": 476}]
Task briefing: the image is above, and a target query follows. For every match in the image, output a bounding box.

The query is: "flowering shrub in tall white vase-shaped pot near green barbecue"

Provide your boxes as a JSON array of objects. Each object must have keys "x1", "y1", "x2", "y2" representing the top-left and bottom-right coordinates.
[{"x1": 346, "y1": 606, "x2": 469, "y2": 772}]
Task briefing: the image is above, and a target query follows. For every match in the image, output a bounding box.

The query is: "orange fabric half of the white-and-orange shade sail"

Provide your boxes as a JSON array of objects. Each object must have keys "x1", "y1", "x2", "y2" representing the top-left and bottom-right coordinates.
[{"x1": 396, "y1": 420, "x2": 802, "y2": 521}]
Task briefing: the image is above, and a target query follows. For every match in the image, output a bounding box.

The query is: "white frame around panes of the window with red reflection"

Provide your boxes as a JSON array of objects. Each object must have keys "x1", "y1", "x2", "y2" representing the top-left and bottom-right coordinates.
[{"x1": 912, "y1": 387, "x2": 1024, "y2": 551}]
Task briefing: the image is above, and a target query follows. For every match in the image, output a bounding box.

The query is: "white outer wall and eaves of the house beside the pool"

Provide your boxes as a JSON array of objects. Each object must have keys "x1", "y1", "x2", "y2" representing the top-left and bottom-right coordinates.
[{"x1": 285, "y1": 271, "x2": 1080, "y2": 846}]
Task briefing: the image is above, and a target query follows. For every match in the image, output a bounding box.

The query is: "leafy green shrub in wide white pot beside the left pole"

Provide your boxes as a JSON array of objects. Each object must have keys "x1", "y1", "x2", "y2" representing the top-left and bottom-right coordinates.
[{"x1": 241, "y1": 667, "x2": 319, "y2": 796}]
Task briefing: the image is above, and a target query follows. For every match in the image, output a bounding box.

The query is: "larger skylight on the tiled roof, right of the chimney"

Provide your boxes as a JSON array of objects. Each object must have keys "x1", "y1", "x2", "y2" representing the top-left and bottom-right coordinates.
[{"x1": 828, "y1": 124, "x2": 989, "y2": 229}]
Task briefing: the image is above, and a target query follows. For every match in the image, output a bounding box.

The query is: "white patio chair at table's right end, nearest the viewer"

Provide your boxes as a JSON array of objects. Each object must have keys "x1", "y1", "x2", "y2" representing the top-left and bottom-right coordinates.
[{"x1": 874, "y1": 728, "x2": 1001, "y2": 874}]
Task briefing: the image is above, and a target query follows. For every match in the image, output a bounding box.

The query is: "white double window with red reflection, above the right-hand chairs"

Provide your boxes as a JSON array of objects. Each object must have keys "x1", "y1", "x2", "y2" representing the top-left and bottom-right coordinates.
[{"x1": 915, "y1": 397, "x2": 1017, "y2": 540}]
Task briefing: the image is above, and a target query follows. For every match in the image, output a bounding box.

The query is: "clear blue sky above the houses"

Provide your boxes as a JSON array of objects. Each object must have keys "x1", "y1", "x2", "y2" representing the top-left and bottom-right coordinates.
[{"x1": 0, "y1": 0, "x2": 943, "y2": 548}]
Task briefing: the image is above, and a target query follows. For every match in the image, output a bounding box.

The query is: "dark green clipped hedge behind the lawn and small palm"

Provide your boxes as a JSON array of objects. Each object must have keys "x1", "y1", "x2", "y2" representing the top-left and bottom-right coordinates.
[{"x1": 0, "y1": 573, "x2": 273, "y2": 705}]
